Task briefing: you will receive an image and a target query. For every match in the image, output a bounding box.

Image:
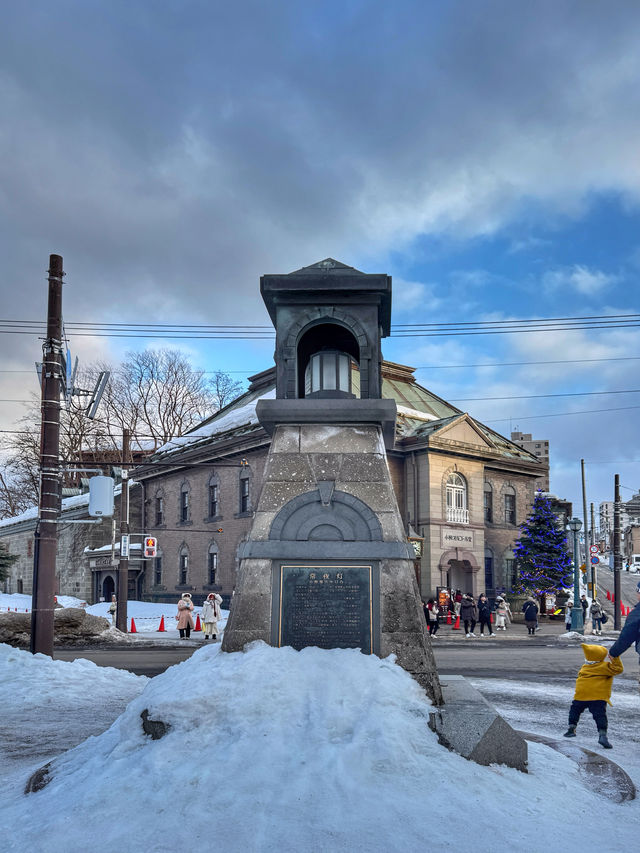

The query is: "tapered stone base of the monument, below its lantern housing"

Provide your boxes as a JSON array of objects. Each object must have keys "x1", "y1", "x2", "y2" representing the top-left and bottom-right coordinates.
[{"x1": 222, "y1": 414, "x2": 442, "y2": 705}]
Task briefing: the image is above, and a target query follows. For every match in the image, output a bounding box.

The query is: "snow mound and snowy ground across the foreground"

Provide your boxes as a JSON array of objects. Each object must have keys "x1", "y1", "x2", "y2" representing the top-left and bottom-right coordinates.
[{"x1": 0, "y1": 643, "x2": 640, "y2": 853}]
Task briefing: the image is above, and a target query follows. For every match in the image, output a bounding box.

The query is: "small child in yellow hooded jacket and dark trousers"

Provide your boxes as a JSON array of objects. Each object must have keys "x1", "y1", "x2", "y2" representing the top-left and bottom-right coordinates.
[{"x1": 564, "y1": 643, "x2": 624, "y2": 749}]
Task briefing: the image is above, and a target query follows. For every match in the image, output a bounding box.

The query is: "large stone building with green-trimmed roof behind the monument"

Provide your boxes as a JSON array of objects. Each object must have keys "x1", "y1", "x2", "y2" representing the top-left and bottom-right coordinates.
[{"x1": 130, "y1": 259, "x2": 547, "y2": 602}]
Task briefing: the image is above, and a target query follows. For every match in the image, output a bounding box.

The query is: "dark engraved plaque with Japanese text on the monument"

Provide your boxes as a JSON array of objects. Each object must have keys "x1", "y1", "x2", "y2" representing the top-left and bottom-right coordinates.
[{"x1": 278, "y1": 565, "x2": 373, "y2": 654}]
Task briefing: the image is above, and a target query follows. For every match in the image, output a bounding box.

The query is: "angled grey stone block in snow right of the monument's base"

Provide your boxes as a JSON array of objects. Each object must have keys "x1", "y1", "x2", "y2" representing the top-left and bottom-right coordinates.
[{"x1": 429, "y1": 675, "x2": 528, "y2": 773}]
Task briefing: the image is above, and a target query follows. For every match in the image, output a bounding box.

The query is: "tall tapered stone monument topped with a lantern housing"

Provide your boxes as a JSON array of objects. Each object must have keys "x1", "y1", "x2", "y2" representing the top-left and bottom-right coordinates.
[{"x1": 222, "y1": 259, "x2": 442, "y2": 705}]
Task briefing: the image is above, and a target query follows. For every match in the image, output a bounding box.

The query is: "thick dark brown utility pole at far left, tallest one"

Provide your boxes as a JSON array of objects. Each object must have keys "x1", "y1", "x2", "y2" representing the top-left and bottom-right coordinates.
[{"x1": 29, "y1": 255, "x2": 64, "y2": 657}]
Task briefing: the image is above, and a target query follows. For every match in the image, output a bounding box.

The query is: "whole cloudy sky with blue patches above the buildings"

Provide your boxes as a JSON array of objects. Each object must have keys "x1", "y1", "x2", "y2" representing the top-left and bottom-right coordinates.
[{"x1": 0, "y1": 0, "x2": 640, "y2": 508}]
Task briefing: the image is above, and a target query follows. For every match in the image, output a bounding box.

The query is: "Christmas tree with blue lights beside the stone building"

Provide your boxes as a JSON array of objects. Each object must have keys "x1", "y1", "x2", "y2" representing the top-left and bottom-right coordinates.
[{"x1": 513, "y1": 492, "x2": 573, "y2": 596}]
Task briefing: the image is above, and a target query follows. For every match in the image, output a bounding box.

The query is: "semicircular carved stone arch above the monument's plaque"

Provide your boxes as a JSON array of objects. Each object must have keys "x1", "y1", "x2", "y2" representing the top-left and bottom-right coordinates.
[{"x1": 269, "y1": 489, "x2": 382, "y2": 542}]
